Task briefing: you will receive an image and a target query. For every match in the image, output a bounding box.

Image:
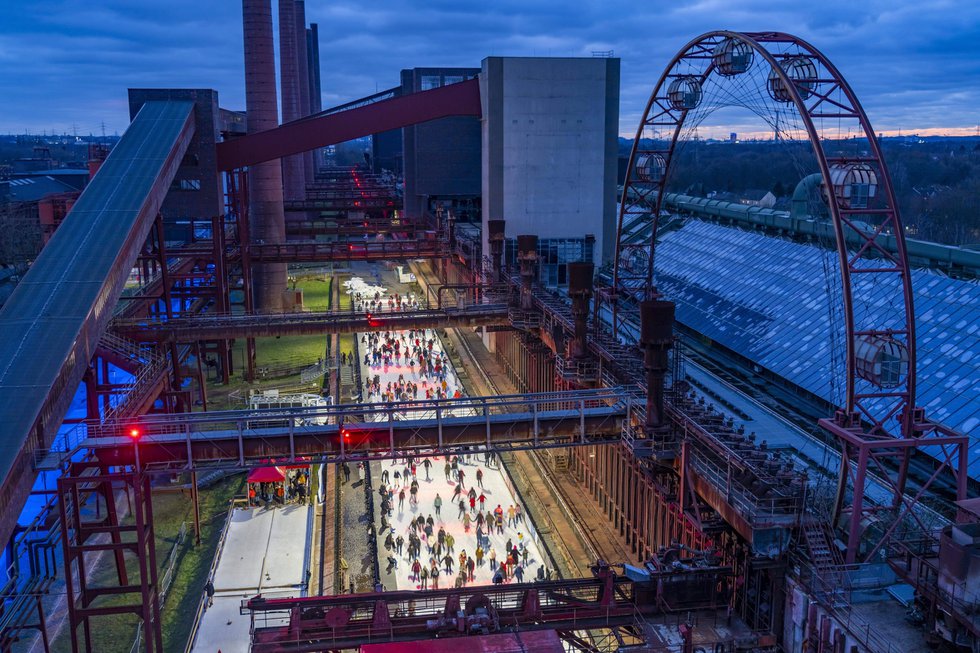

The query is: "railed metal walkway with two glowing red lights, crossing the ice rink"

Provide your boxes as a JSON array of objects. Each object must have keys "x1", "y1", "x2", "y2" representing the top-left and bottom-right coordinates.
[{"x1": 39, "y1": 388, "x2": 633, "y2": 470}]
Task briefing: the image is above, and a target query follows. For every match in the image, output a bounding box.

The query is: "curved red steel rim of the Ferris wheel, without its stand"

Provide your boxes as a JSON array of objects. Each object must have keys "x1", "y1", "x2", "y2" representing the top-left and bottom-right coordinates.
[{"x1": 613, "y1": 31, "x2": 916, "y2": 437}]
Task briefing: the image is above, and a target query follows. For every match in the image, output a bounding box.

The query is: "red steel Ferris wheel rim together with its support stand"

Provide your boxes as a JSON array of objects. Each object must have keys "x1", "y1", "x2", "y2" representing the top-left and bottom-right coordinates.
[{"x1": 611, "y1": 31, "x2": 967, "y2": 562}]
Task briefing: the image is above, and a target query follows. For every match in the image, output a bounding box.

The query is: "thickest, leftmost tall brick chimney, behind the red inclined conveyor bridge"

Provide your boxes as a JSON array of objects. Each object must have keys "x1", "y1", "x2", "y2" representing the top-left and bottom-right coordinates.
[{"x1": 242, "y1": 0, "x2": 286, "y2": 311}]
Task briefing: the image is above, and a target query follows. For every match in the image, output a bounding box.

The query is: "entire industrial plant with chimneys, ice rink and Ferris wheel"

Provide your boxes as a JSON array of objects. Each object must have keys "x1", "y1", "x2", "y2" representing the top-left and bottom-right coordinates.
[{"x1": 0, "y1": 8, "x2": 980, "y2": 653}]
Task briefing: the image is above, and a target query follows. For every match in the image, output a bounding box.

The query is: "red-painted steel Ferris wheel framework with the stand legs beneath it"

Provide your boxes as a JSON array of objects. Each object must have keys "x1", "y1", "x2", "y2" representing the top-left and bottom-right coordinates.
[{"x1": 612, "y1": 31, "x2": 966, "y2": 562}]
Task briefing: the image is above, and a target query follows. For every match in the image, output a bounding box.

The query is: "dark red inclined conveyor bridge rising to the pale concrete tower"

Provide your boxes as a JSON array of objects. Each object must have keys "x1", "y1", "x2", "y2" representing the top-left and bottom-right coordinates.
[{"x1": 217, "y1": 77, "x2": 481, "y2": 170}]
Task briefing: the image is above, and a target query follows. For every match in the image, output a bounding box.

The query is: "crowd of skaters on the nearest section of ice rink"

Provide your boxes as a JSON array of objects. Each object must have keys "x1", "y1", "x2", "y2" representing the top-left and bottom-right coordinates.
[{"x1": 378, "y1": 453, "x2": 548, "y2": 589}]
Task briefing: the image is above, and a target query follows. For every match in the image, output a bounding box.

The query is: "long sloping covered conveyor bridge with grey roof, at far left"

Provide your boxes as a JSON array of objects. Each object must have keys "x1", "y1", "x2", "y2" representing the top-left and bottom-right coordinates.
[{"x1": 0, "y1": 101, "x2": 194, "y2": 542}]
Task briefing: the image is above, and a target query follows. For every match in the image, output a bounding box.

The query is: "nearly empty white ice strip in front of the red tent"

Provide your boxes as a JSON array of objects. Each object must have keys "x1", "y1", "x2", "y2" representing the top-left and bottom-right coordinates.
[{"x1": 192, "y1": 504, "x2": 310, "y2": 653}]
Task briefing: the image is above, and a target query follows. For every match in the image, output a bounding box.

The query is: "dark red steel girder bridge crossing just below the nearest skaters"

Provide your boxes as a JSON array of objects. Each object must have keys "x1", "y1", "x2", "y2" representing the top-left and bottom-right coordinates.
[{"x1": 242, "y1": 562, "x2": 731, "y2": 653}]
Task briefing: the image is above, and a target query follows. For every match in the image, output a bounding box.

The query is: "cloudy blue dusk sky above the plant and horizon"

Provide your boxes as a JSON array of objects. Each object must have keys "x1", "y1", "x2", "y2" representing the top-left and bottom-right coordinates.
[{"x1": 0, "y1": 0, "x2": 980, "y2": 135}]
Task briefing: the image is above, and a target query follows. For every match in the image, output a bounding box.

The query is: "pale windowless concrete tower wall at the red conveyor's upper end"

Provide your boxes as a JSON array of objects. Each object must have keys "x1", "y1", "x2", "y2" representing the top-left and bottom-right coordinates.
[{"x1": 480, "y1": 57, "x2": 619, "y2": 263}]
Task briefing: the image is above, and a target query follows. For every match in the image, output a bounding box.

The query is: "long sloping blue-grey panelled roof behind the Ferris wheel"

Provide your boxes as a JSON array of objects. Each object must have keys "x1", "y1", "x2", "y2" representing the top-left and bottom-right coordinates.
[{"x1": 655, "y1": 219, "x2": 980, "y2": 478}]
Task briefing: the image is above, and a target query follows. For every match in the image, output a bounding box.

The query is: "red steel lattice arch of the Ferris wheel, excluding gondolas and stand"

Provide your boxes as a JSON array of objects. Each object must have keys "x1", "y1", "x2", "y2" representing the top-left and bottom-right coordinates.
[{"x1": 613, "y1": 31, "x2": 915, "y2": 437}]
